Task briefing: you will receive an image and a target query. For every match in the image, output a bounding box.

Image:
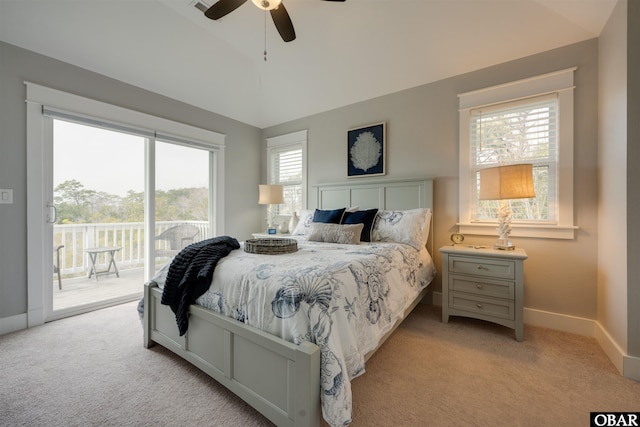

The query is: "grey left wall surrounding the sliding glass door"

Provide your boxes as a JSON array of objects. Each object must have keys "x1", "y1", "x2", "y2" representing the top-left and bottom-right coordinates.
[{"x1": 0, "y1": 42, "x2": 261, "y2": 319}]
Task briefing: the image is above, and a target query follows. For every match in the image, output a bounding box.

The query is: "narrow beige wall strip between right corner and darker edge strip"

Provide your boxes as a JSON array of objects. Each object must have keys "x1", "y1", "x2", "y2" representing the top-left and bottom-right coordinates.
[{"x1": 598, "y1": 2, "x2": 632, "y2": 356}]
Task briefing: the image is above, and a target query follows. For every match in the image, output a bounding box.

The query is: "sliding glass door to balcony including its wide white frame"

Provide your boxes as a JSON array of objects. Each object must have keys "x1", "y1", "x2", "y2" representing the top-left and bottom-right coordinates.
[{"x1": 25, "y1": 82, "x2": 225, "y2": 327}]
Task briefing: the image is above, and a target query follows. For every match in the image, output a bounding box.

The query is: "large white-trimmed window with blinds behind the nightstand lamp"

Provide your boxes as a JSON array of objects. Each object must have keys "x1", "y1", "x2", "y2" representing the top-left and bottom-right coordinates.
[{"x1": 457, "y1": 67, "x2": 577, "y2": 239}]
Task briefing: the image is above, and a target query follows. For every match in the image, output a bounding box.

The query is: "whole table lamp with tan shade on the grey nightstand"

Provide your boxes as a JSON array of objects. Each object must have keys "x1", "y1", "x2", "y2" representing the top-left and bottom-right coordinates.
[{"x1": 478, "y1": 164, "x2": 536, "y2": 250}]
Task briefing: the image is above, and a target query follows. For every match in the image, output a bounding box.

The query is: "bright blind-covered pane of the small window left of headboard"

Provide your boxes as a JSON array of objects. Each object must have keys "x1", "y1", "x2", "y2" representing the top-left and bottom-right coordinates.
[{"x1": 270, "y1": 144, "x2": 303, "y2": 215}]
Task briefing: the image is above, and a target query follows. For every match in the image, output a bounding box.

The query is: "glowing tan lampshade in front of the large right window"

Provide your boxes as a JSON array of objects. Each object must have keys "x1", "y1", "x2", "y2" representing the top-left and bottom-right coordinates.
[{"x1": 478, "y1": 164, "x2": 536, "y2": 200}]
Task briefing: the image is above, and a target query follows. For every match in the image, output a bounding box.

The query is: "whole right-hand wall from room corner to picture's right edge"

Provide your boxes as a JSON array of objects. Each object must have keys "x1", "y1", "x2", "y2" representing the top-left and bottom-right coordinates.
[{"x1": 598, "y1": 0, "x2": 640, "y2": 364}]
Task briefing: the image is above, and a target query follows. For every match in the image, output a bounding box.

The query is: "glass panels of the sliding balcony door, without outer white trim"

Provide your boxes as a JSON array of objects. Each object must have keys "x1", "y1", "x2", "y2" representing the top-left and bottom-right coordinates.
[{"x1": 47, "y1": 118, "x2": 216, "y2": 318}]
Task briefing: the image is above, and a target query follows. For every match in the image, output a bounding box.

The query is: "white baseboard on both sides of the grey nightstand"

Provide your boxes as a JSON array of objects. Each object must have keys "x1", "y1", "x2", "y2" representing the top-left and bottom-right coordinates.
[{"x1": 433, "y1": 292, "x2": 640, "y2": 381}]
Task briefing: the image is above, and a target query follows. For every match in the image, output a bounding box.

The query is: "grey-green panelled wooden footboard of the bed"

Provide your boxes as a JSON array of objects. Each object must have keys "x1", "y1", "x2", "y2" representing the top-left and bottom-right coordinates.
[{"x1": 144, "y1": 283, "x2": 321, "y2": 426}]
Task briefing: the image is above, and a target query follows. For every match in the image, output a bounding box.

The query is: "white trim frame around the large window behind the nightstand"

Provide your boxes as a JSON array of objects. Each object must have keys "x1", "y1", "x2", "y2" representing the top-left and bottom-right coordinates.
[{"x1": 456, "y1": 67, "x2": 578, "y2": 239}]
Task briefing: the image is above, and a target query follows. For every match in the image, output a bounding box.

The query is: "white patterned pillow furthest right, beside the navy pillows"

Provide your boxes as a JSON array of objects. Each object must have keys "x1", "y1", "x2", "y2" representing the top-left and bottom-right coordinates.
[{"x1": 371, "y1": 208, "x2": 431, "y2": 250}]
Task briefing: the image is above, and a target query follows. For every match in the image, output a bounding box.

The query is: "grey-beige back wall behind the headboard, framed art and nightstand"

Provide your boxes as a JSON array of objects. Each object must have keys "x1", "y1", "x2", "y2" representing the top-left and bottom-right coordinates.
[{"x1": 262, "y1": 39, "x2": 598, "y2": 319}]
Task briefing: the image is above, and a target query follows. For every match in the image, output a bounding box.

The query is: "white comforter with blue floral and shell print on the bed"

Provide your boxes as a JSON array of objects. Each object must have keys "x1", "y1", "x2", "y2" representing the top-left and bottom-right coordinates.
[{"x1": 154, "y1": 240, "x2": 435, "y2": 426}]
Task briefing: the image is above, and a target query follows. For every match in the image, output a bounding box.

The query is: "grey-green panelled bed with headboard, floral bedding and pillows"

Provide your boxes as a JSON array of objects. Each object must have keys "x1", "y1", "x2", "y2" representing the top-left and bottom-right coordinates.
[{"x1": 143, "y1": 179, "x2": 435, "y2": 426}]
